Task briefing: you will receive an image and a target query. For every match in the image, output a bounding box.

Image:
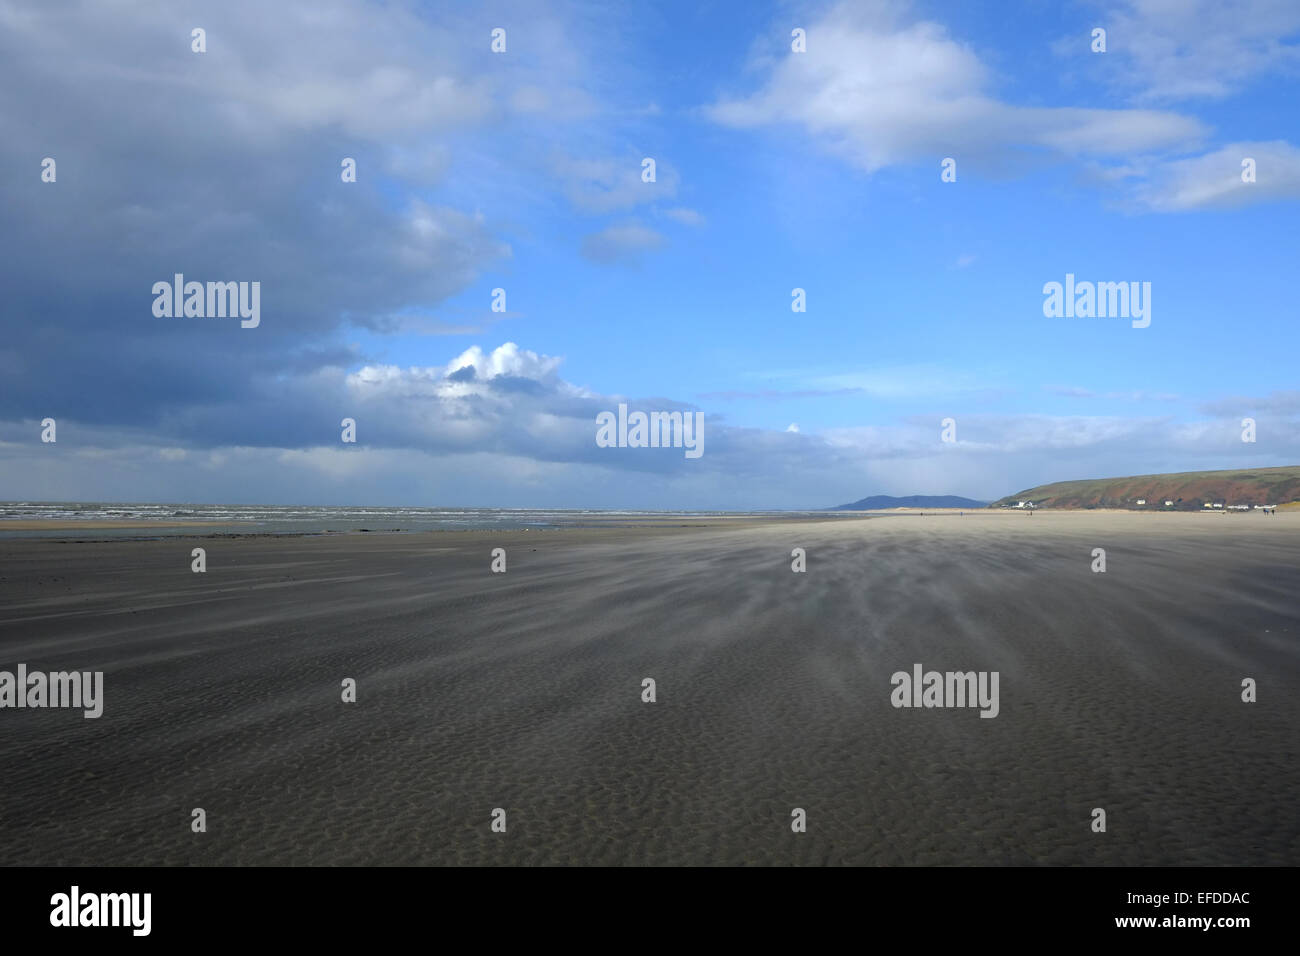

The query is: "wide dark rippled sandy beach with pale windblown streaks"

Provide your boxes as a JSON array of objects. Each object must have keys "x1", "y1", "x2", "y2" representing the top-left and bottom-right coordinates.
[{"x1": 0, "y1": 511, "x2": 1300, "y2": 865}]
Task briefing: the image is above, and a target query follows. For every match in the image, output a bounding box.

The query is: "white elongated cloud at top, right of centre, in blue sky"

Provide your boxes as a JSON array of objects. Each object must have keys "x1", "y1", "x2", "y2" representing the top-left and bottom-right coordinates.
[{"x1": 705, "y1": 4, "x2": 1203, "y2": 172}]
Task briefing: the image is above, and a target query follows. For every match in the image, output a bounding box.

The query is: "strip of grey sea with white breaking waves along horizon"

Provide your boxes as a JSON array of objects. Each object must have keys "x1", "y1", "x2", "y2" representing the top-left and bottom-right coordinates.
[{"x1": 0, "y1": 501, "x2": 836, "y2": 538}]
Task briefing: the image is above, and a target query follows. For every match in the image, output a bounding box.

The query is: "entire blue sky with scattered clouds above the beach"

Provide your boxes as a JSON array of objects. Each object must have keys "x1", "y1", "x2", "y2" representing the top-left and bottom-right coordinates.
[{"x1": 0, "y1": 0, "x2": 1300, "y2": 510}]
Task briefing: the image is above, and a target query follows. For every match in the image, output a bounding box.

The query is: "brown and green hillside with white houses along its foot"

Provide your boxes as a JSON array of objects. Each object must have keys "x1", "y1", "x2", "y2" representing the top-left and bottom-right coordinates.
[{"x1": 989, "y1": 464, "x2": 1300, "y2": 511}]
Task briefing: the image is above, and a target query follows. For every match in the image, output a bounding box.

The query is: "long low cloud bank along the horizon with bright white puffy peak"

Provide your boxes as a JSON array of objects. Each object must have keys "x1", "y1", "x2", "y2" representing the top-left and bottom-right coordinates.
[{"x1": 0, "y1": 342, "x2": 1300, "y2": 509}]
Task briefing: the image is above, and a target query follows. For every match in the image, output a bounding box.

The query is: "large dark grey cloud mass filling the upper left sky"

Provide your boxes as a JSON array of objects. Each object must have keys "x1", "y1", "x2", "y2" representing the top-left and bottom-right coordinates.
[{"x1": 0, "y1": 0, "x2": 634, "y2": 437}]
